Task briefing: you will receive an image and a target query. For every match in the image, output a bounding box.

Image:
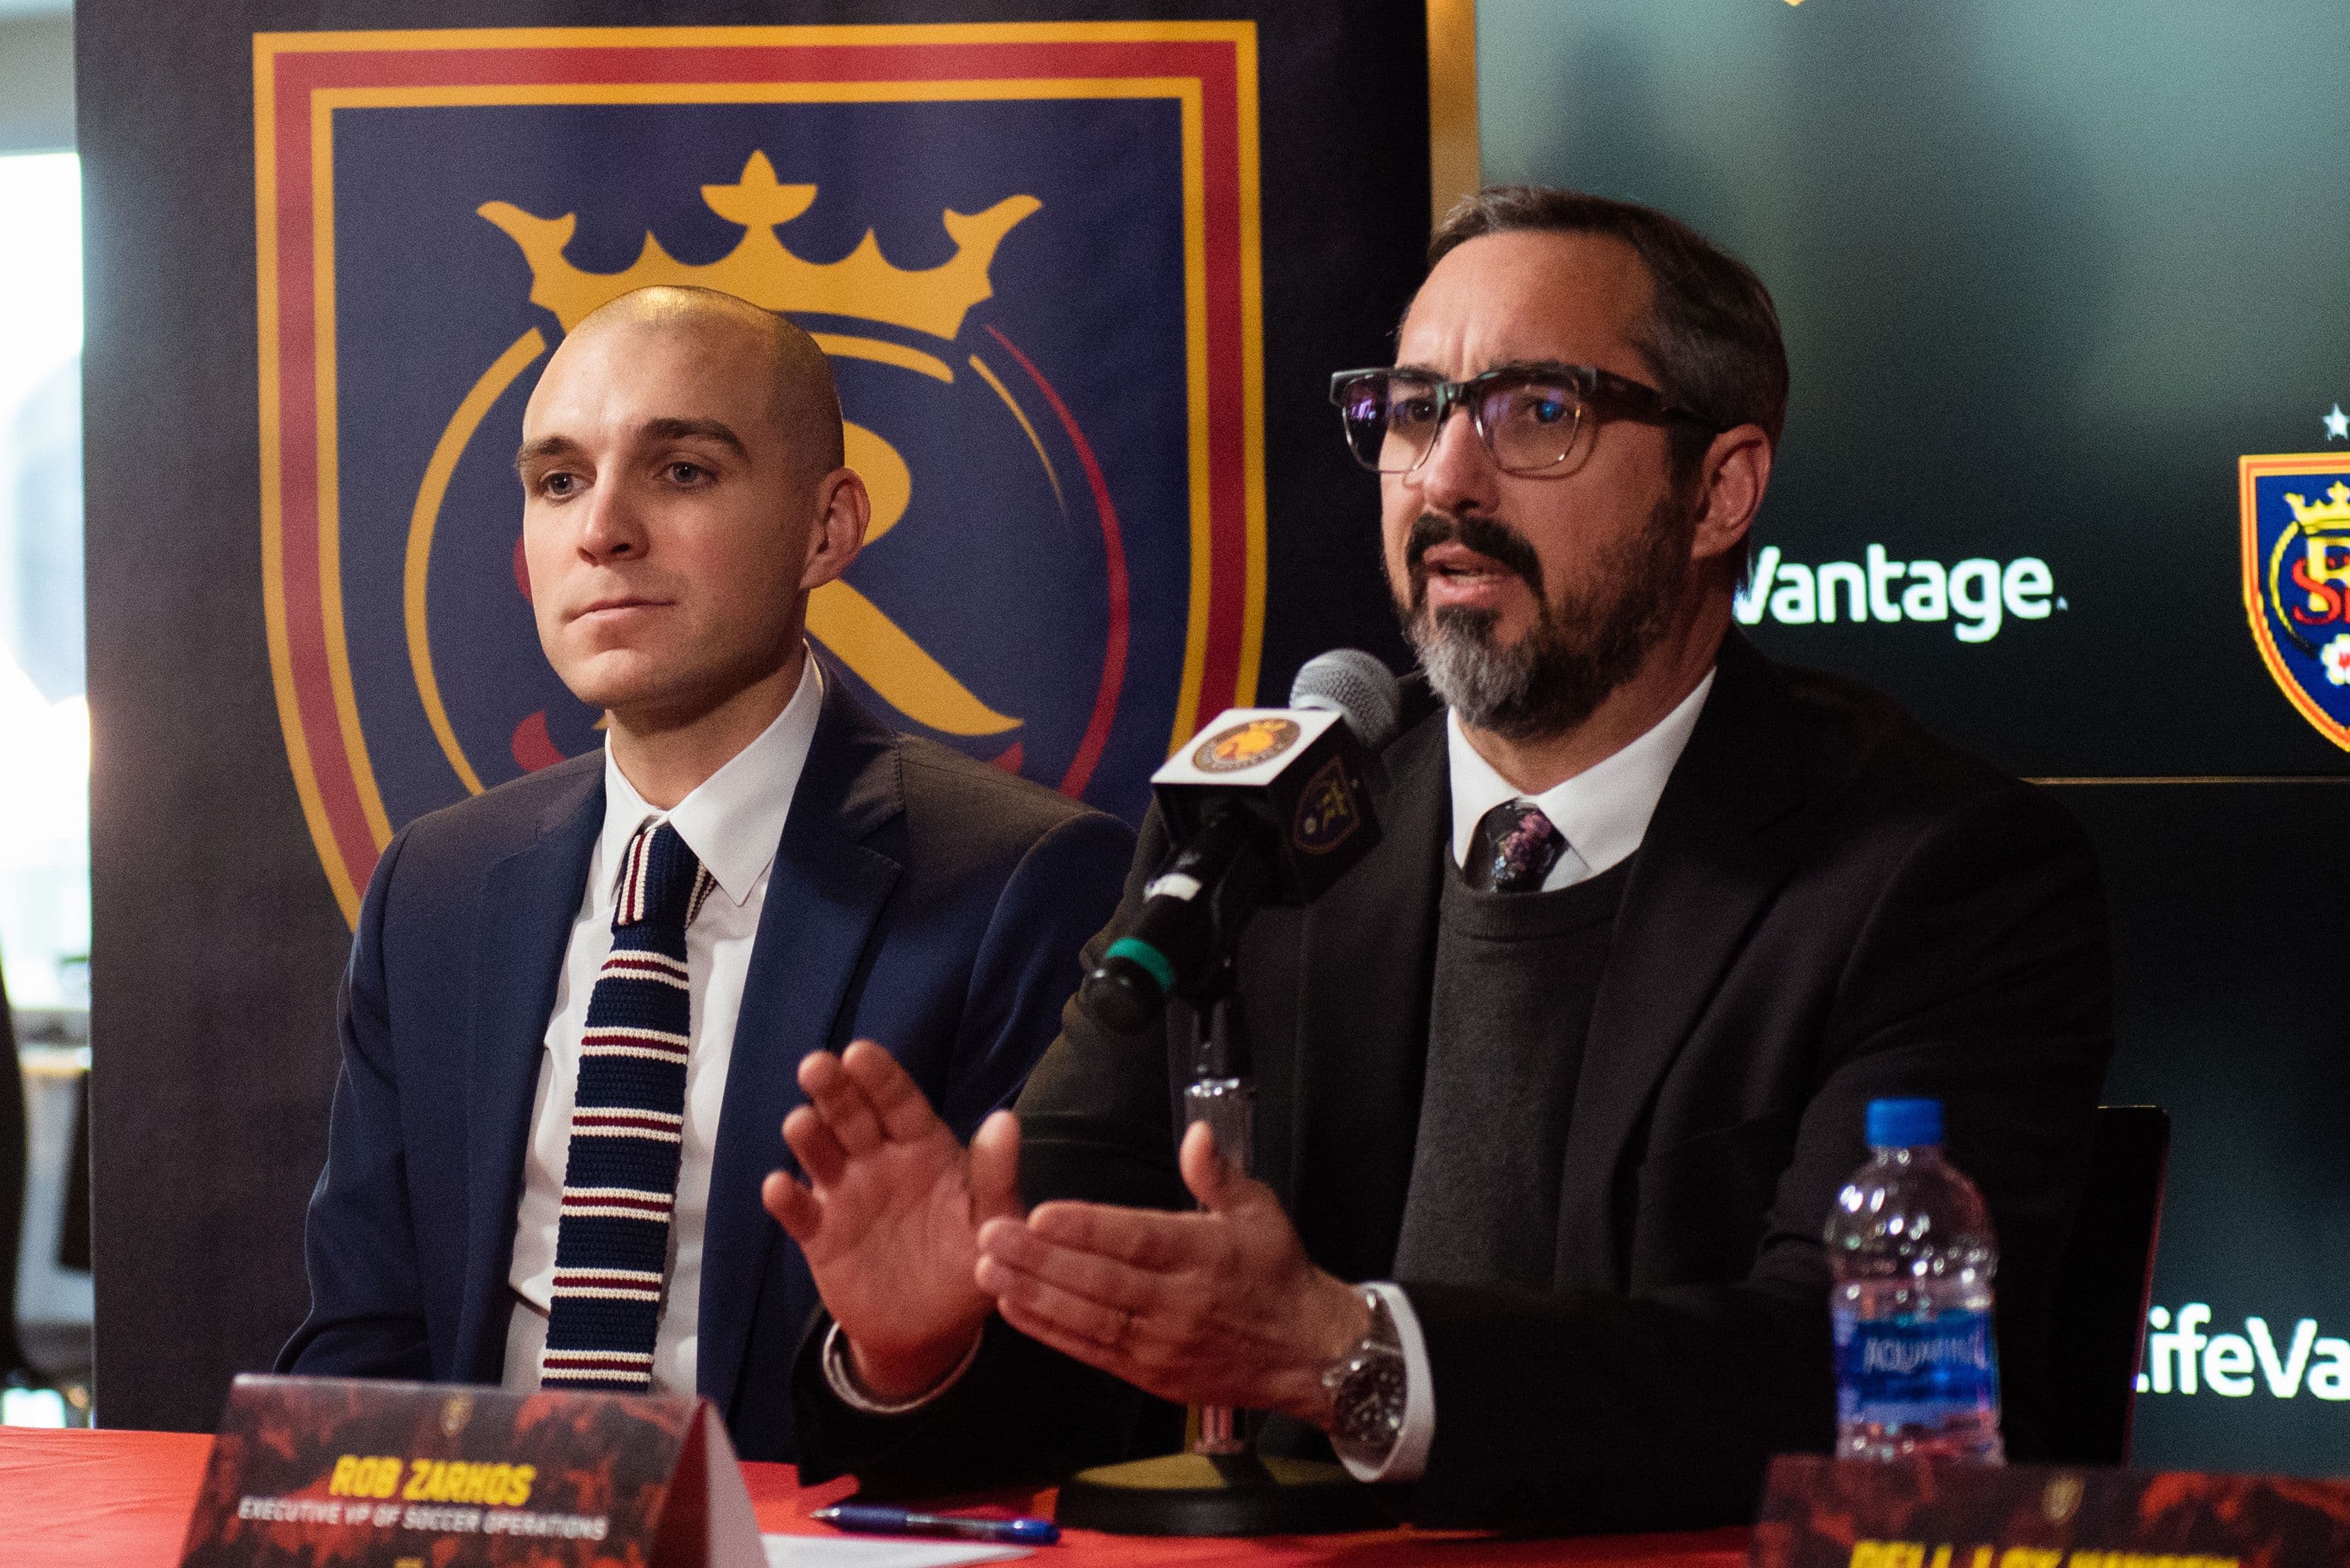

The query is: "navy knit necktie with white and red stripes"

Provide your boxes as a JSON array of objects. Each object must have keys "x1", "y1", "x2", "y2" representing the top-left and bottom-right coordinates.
[{"x1": 538, "y1": 823, "x2": 717, "y2": 1394}]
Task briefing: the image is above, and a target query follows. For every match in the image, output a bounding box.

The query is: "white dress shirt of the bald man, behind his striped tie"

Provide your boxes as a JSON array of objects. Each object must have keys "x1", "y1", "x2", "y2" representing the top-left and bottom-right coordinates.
[{"x1": 503, "y1": 654, "x2": 825, "y2": 1394}]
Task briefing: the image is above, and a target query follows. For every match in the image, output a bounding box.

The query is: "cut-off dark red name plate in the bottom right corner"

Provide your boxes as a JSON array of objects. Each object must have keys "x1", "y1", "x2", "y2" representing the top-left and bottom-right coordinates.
[{"x1": 1751, "y1": 1455, "x2": 2350, "y2": 1568}]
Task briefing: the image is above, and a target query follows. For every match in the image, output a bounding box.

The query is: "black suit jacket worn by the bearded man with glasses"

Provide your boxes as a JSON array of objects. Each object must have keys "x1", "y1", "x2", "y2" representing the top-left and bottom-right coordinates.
[{"x1": 799, "y1": 633, "x2": 2110, "y2": 1530}]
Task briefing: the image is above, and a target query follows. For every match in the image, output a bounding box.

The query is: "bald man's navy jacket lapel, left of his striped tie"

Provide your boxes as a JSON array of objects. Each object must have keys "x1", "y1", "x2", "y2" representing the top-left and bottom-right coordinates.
[{"x1": 459, "y1": 750, "x2": 604, "y2": 1383}]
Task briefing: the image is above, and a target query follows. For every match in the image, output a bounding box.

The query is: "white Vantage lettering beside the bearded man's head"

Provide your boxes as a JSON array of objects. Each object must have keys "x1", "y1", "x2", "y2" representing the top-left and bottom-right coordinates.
[{"x1": 1734, "y1": 546, "x2": 2066, "y2": 642}]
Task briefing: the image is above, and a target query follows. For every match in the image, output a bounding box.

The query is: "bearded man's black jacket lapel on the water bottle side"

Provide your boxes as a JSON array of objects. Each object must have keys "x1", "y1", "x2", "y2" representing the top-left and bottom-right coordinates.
[{"x1": 1556, "y1": 633, "x2": 1809, "y2": 1291}]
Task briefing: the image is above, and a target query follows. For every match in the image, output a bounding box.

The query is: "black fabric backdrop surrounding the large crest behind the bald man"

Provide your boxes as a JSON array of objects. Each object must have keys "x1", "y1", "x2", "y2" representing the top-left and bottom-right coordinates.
[{"x1": 75, "y1": 0, "x2": 1429, "y2": 1429}]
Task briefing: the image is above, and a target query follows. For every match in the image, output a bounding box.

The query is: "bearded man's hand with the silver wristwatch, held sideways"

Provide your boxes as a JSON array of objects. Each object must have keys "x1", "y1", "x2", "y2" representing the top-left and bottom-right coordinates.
[{"x1": 978, "y1": 1126, "x2": 1370, "y2": 1424}]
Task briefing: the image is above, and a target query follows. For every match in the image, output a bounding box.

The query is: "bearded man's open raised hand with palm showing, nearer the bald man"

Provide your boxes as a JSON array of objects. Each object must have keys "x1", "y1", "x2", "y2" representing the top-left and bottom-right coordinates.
[{"x1": 759, "y1": 1039, "x2": 1020, "y2": 1399}]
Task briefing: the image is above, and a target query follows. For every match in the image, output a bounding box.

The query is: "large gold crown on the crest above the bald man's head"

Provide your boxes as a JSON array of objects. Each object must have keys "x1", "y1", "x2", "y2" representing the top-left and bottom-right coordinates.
[{"x1": 477, "y1": 153, "x2": 1044, "y2": 338}]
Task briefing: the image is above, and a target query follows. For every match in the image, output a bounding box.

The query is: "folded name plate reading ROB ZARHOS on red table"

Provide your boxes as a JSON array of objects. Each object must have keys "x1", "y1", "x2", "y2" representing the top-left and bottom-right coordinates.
[{"x1": 181, "y1": 1378, "x2": 766, "y2": 1568}]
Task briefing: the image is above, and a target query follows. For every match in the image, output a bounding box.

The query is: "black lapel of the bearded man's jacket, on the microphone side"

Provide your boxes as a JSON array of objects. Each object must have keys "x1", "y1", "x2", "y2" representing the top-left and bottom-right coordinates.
[{"x1": 1290, "y1": 717, "x2": 1452, "y2": 1279}]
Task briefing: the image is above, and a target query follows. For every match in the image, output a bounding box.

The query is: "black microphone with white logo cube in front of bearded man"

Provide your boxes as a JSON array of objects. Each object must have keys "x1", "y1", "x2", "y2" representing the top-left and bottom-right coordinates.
[{"x1": 1078, "y1": 649, "x2": 1403, "y2": 1034}]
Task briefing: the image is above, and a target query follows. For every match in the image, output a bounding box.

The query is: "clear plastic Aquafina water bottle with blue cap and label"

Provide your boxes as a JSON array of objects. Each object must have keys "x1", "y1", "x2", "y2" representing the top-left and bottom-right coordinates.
[{"x1": 1828, "y1": 1100, "x2": 2007, "y2": 1465}]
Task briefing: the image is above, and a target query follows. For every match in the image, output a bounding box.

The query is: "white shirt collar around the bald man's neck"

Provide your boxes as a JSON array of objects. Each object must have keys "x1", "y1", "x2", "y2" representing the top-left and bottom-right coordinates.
[{"x1": 599, "y1": 651, "x2": 825, "y2": 905}]
